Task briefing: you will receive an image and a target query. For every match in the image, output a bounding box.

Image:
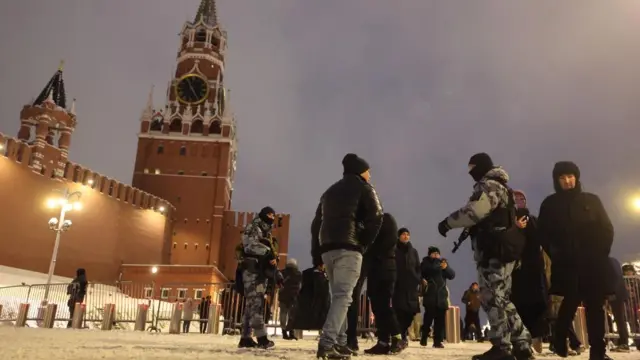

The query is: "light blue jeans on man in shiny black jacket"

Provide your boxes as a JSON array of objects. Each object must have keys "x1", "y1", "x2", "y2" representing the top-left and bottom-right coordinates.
[{"x1": 319, "y1": 250, "x2": 362, "y2": 349}]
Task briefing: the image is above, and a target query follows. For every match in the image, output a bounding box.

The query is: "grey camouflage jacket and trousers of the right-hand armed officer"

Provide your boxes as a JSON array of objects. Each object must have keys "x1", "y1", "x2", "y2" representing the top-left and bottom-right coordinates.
[{"x1": 446, "y1": 167, "x2": 531, "y2": 351}]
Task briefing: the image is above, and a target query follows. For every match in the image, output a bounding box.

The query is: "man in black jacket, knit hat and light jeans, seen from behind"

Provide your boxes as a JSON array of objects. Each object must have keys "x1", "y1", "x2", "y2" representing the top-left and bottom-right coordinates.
[{"x1": 311, "y1": 154, "x2": 382, "y2": 359}]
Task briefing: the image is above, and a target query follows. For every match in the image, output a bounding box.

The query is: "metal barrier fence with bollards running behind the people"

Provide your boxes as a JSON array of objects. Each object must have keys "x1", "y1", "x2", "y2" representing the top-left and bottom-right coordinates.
[{"x1": 13, "y1": 276, "x2": 640, "y2": 344}]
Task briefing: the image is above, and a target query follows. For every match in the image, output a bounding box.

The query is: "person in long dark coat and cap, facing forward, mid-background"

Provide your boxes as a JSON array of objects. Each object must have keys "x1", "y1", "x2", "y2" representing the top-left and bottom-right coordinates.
[{"x1": 392, "y1": 228, "x2": 421, "y2": 344}]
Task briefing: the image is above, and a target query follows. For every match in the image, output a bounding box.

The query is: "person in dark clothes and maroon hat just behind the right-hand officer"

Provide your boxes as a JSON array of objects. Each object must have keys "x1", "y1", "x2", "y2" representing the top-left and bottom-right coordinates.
[{"x1": 511, "y1": 190, "x2": 549, "y2": 353}]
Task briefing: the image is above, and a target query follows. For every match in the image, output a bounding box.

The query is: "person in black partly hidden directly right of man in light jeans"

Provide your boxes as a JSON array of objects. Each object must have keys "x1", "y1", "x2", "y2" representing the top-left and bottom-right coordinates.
[{"x1": 364, "y1": 213, "x2": 404, "y2": 355}]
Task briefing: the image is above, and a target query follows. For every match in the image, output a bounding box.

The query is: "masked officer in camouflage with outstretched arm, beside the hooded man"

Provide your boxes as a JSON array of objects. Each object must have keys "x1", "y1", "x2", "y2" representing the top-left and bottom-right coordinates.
[{"x1": 438, "y1": 153, "x2": 534, "y2": 360}]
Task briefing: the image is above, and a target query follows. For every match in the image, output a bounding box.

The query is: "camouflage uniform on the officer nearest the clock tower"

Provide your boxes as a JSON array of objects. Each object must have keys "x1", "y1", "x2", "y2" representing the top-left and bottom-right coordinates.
[{"x1": 242, "y1": 217, "x2": 271, "y2": 338}]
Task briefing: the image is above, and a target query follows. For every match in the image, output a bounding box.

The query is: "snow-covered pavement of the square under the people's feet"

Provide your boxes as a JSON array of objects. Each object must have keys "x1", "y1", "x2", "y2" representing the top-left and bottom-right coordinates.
[{"x1": 0, "y1": 325, "x2": 640, "y2": 360}]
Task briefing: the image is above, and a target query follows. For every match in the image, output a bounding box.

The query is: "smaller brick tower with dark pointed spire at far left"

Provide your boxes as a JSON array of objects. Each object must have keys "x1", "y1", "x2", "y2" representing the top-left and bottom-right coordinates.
[{"x1": 18, "y1": 63, "x2": 76, "y2": 179}]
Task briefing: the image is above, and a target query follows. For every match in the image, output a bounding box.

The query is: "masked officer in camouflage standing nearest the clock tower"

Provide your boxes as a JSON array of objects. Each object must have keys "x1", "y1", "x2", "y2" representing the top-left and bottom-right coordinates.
[{"x1": 238, "y1": 206, "x2": 277, "y2": 349}]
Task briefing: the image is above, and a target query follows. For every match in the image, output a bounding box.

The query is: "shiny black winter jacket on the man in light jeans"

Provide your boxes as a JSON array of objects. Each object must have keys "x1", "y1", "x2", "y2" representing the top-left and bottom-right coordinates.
[{"x1": 311, "y1": 174, "x2": 382, "y2": 262}]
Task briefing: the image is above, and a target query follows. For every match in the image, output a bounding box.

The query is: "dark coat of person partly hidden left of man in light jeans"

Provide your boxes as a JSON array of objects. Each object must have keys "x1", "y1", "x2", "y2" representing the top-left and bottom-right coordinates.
[{"x1": 290, "y1": 260, "x2": 331, "y2": 330}]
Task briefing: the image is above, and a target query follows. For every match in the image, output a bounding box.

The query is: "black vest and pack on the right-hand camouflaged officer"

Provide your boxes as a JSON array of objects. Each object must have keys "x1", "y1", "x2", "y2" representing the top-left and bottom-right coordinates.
[{"x1": 478, "y1": 184, "x2": 527, "y2": 264}]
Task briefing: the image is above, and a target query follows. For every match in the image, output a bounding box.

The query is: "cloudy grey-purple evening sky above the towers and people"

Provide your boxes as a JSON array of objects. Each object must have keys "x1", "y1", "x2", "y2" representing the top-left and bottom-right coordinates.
[{"x1": 0, "y1": 0, "x2": 640, "y2": 302}]
